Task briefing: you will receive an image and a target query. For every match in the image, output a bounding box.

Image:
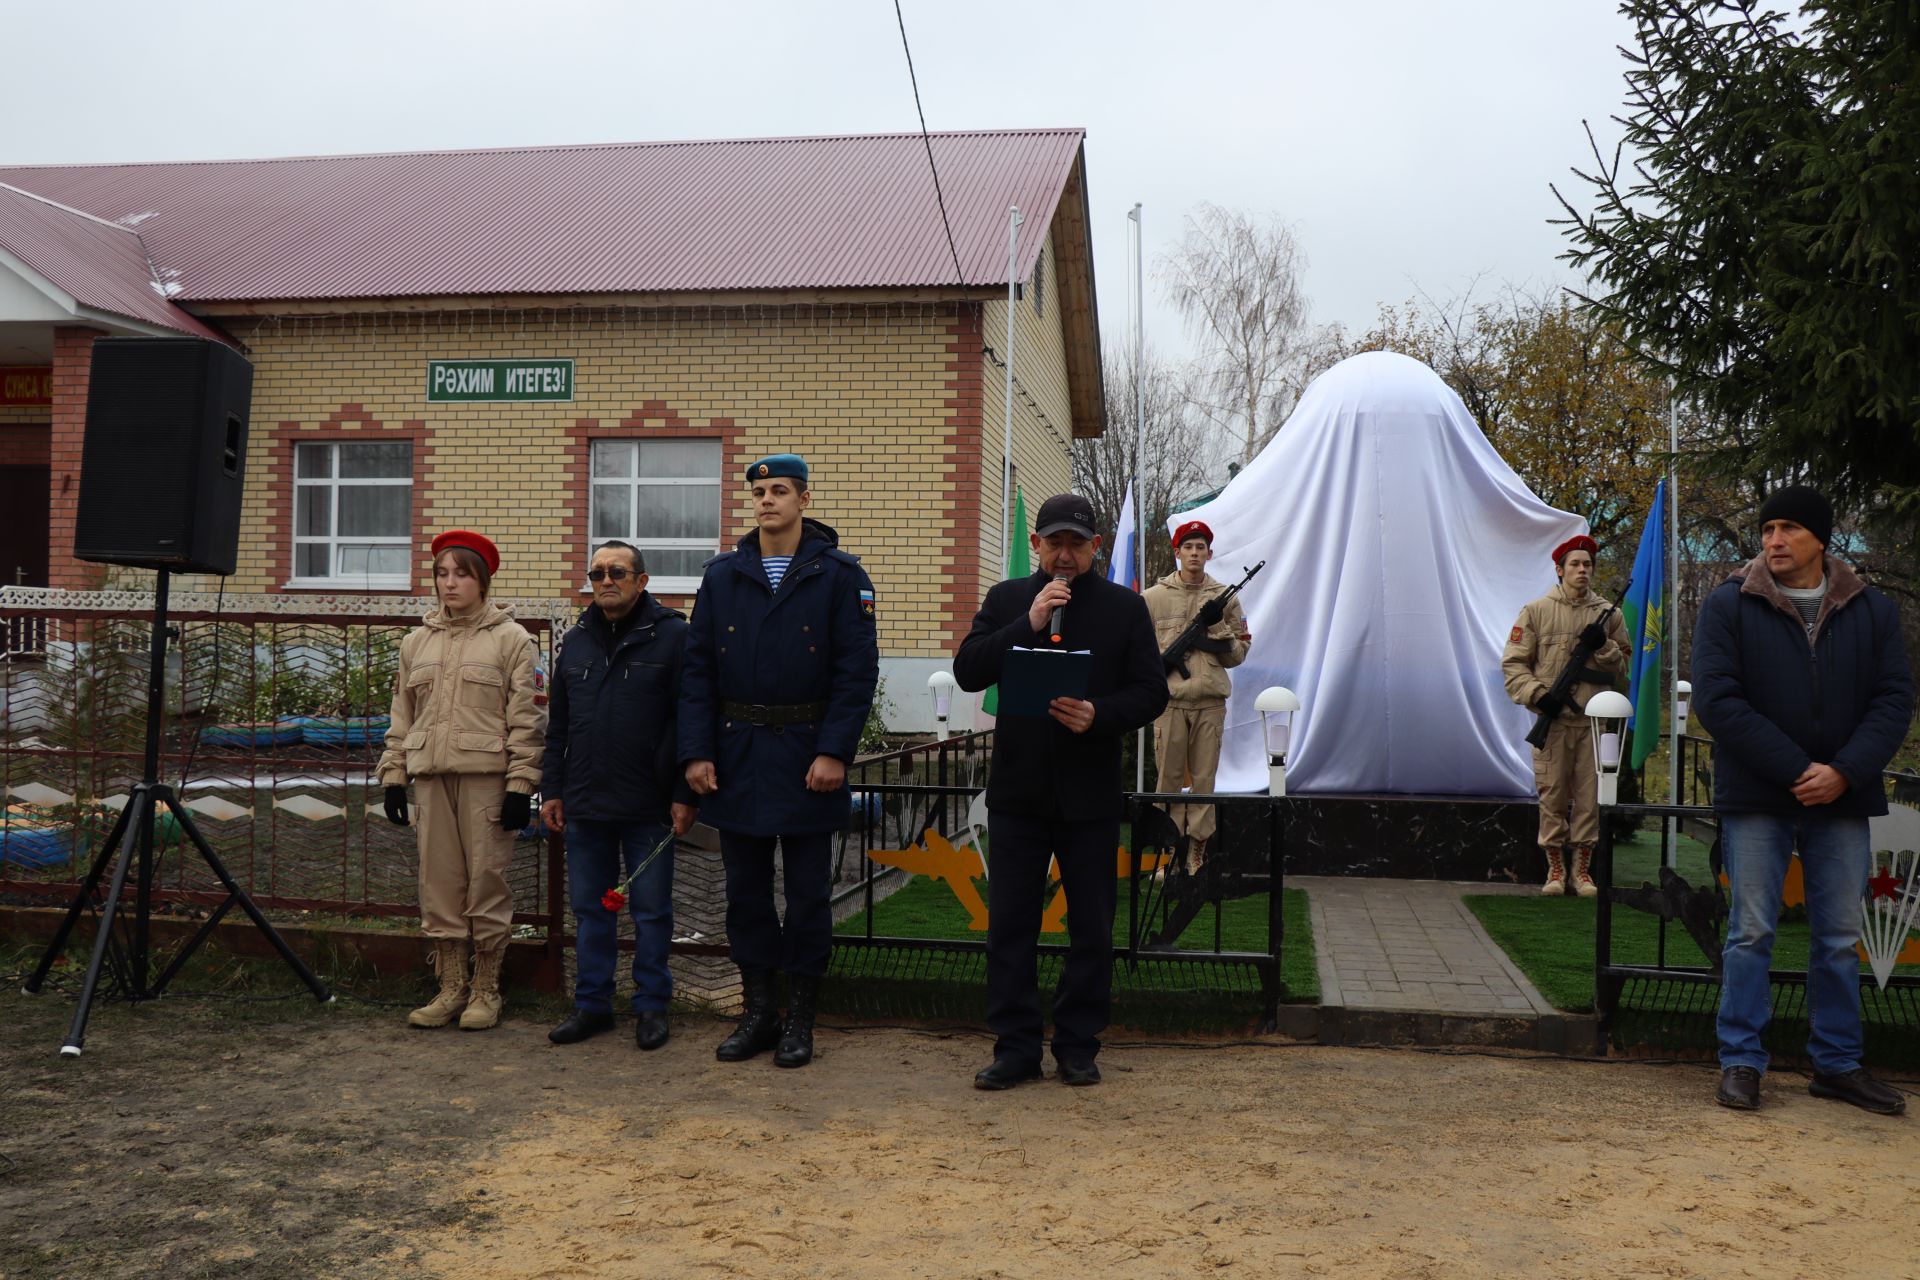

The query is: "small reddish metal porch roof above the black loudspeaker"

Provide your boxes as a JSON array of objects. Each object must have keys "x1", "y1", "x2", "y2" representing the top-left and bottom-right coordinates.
[{"x1": 0, "y1": 184, "x2": 219, "y2": 338}]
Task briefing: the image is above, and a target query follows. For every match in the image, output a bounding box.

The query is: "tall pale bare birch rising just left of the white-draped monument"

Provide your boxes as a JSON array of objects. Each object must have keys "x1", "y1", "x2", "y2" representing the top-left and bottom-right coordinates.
[{"x1": 1156, "y1": 203, "x2": 1308, "y2": 466}]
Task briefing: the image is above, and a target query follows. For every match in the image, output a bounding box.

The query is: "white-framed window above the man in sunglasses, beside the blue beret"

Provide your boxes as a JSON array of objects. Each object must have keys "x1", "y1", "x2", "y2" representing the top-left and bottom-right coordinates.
[{"x1": 588, "y1": 439, "x2": 720, "y2": 591}]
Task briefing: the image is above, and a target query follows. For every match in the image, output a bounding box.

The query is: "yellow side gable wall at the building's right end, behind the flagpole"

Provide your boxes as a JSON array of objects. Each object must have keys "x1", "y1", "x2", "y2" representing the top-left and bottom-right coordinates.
[{"x1": 979, "y1": 232, "x2": 1104, "y2": 581}]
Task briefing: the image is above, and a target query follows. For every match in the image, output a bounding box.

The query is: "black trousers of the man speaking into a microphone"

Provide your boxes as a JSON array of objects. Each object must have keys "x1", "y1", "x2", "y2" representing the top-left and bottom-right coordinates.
[{"x1": 987, "y1": 810, "x2": 1119, "y2": 1063}]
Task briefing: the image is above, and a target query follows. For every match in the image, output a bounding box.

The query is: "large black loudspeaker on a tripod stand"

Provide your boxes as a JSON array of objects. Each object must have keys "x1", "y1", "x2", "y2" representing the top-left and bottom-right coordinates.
[{"x1": 73, "y1": 338, "x2": 253, "y2": 574}]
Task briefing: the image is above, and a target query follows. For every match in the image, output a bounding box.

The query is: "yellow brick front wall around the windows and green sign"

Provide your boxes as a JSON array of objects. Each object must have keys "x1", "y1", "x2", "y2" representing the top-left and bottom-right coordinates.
[{"x1": 182, "y1": 305, "x2": 1006, "y2": 656}]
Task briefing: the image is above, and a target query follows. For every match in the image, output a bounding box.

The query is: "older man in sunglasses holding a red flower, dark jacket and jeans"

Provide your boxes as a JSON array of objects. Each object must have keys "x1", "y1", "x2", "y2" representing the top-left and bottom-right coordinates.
[{"x1": 540, "y1": 541, "x2": 697, "y2": 1050}]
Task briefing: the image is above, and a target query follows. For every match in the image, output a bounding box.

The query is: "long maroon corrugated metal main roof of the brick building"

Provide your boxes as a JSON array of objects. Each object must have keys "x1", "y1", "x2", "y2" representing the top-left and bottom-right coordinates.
[{"x1": 0, "y1": 129, "x2": 1085, "y2": 303}]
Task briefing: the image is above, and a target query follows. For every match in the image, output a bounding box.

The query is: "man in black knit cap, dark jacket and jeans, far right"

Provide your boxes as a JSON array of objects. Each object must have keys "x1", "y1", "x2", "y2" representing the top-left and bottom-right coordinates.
[{"x1": 1693, "y1": 486, "x2": 1914, "y2": 1115}]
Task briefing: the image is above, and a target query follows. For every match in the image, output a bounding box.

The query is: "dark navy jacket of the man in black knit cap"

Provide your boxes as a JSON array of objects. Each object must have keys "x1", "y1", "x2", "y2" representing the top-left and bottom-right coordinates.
[{"x1": 1693, "y1": 557, "x2": 1914, "y2": 818}]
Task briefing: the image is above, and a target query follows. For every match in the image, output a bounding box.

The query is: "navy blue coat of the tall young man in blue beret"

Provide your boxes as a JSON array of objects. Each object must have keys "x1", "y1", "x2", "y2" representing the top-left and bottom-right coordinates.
[{"x1": 680, "y1": 520, "x2": 879, "y2": 835}]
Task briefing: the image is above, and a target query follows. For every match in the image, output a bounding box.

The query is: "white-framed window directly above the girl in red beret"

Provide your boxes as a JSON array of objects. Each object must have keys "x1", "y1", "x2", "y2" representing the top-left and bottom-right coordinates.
[{"x1": 292, "y1": 439, "x2": 413, "y2": 589}]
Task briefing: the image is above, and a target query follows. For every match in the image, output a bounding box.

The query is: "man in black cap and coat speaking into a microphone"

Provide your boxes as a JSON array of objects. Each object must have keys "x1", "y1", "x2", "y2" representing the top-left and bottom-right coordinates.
[{"x1": 954, "y1": 493, "x2": 1167, "y2": 1088}]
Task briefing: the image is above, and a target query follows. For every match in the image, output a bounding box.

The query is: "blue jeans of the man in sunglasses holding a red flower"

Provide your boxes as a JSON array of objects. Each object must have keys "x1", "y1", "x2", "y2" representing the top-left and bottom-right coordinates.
[{"x1": 566, "y1": 818, "x2": 674, "y2": 1013}]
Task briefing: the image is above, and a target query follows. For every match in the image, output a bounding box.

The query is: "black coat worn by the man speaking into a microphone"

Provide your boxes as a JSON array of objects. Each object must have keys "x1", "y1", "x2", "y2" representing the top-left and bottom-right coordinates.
[{"x1": 954, "y1": 574, "x2": 1167, "y2": 821}]
